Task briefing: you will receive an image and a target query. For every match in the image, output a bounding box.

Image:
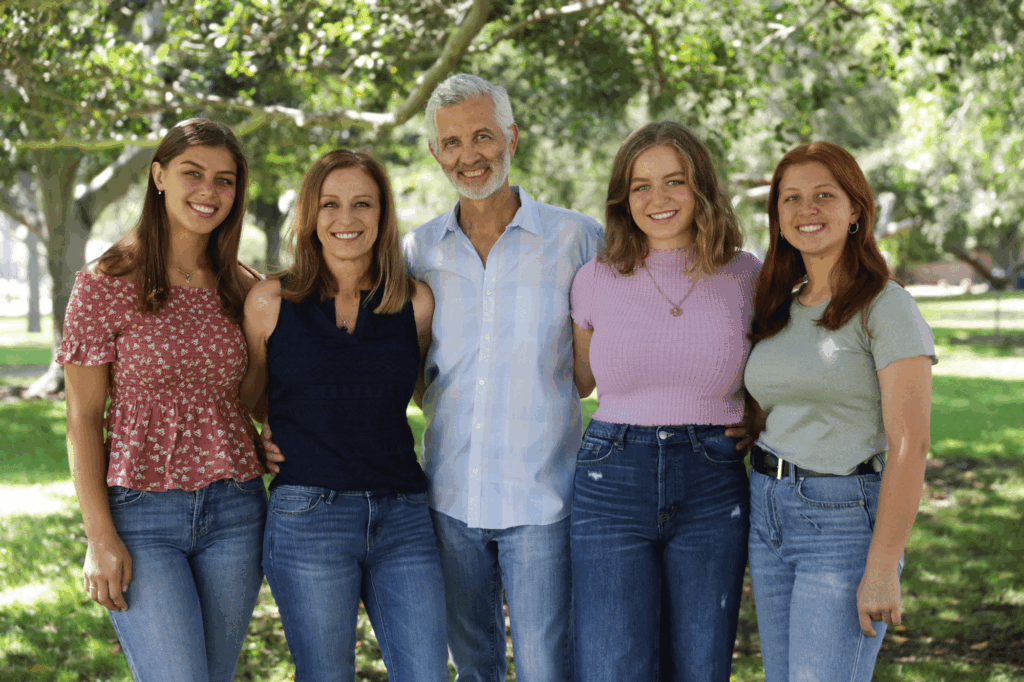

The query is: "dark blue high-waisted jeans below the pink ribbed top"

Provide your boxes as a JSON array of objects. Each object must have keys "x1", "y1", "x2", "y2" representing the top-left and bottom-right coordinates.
[{"x1": 572, "y1": 420, "x2": 750, "y2": 682}]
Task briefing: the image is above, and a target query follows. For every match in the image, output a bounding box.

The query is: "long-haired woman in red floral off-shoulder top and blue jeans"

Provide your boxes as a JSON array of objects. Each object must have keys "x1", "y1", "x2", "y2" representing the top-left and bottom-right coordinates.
[{"x1": 57, "y1": 119, "x2": 266, "y2": 681}]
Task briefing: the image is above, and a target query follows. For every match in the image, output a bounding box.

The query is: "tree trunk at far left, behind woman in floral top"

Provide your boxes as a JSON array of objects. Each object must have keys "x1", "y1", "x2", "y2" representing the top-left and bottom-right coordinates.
[{"x1": 25, "y1": 150, "x2": 84, "y2": 397}]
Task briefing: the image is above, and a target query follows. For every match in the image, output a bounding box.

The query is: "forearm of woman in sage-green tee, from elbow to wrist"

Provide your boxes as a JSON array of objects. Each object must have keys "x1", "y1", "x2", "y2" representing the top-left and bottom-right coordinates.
[{"x1": 867, "y1": 437, "x2": 929, "y2": 570}]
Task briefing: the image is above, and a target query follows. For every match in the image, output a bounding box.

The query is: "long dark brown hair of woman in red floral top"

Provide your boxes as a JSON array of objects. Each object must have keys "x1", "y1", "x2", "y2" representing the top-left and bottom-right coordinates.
[{"x1": 96, "y1": 119, "x2": 249, "y2": 322}]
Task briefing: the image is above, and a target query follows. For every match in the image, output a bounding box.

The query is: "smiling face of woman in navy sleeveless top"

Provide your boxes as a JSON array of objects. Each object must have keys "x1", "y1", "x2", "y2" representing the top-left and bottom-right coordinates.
[{"x1": 316, "y1": 168, "x2": 381, "y2": 268}]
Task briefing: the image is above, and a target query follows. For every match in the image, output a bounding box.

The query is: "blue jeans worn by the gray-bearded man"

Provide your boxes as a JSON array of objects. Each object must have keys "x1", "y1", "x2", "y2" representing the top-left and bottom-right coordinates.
[{"x1": 430, "y1": 510, "x2": 572, "y2": 682}]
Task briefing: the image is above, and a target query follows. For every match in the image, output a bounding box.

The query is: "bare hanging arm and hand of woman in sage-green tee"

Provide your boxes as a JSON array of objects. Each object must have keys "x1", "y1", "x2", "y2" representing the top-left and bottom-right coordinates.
[{"x1": 857, "y1": 355, "x2": 932, "y2": 637}]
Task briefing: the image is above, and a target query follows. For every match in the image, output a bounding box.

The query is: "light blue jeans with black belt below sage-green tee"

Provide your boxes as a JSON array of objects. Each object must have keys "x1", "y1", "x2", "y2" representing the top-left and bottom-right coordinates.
[{"x1": 750, "y1": 464, "x2": 903, "y2": 682}]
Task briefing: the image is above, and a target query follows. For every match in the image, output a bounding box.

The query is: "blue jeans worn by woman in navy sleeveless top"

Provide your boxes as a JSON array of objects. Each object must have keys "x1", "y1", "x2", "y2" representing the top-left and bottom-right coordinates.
[{"x1": 263, "y1": 485, "x2": 449, "y2": 682}]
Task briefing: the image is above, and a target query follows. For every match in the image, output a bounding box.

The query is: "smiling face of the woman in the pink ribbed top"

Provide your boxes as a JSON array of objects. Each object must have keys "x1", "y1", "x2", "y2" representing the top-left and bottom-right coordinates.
[{"x1": 630, "y1": 145, "x2": 695, "y2": 251}]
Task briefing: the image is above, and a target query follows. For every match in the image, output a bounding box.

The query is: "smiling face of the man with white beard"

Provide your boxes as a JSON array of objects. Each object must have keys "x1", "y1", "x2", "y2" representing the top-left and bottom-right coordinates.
[{"x1": 430, "y1": 95, "x2": 519, "y2": 200}]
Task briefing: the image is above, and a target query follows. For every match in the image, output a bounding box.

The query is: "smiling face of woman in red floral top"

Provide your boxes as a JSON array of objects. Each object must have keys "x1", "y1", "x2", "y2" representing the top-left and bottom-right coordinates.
[{"x1": 151, "y1": 146, "x2": 238, "y2": 236}]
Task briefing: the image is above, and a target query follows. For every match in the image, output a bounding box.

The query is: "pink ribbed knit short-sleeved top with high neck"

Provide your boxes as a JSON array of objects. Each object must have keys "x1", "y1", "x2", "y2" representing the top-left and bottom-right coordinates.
[{"x1": 571, "y1": 249, "x2": 761, "y2": 426}]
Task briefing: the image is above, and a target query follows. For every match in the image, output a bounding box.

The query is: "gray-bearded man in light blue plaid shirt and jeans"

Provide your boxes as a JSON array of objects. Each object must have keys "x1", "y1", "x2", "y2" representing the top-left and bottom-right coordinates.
[{"x1": 402, "y1": 74, "x2": 602, "y2": 682}]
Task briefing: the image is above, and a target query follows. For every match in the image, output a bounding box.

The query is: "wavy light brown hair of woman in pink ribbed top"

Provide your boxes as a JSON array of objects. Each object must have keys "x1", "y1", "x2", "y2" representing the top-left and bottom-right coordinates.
[{"x1": 598, "y1": 121, "x2": 743, "y2": 275}]
